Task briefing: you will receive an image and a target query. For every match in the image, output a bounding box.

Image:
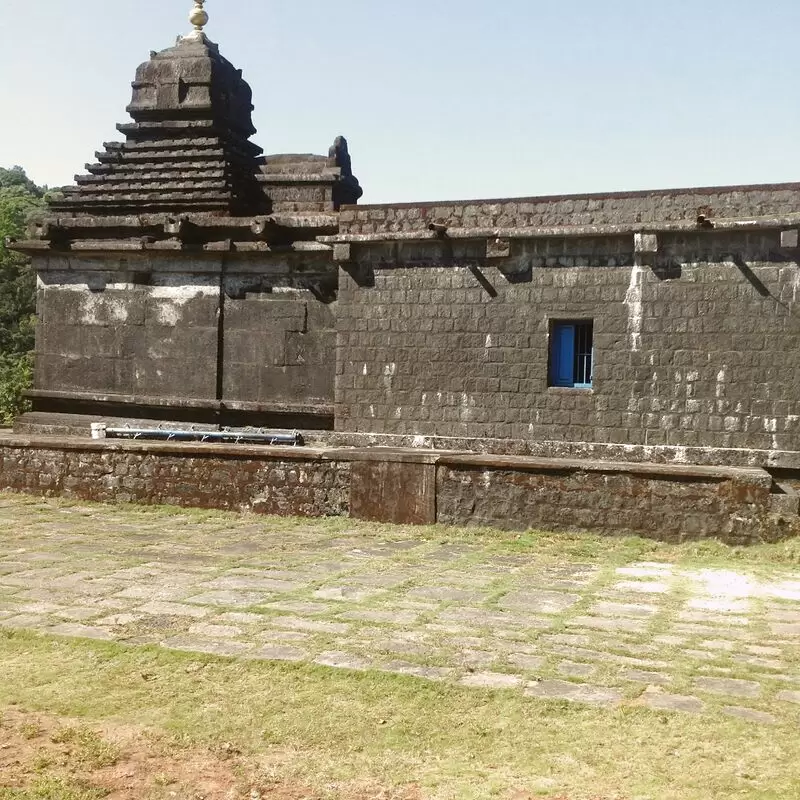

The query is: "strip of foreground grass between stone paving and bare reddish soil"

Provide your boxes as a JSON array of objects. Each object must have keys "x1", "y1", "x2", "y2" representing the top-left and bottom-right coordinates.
[{"x1": 0, "y1": 634, "x2": 800, "y2": 800}]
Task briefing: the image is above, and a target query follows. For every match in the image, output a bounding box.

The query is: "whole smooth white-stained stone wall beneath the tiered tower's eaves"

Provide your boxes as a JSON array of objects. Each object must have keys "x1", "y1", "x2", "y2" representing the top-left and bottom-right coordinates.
[{"x1": 34, "y1": 253, "x2": 336, "y2": 418}]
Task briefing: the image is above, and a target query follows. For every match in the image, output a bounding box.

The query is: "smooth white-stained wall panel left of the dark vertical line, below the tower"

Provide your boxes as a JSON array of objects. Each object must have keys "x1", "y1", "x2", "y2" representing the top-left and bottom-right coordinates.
[{"x1": 34, "y1": 263, "x2": 219, "y2": 400}]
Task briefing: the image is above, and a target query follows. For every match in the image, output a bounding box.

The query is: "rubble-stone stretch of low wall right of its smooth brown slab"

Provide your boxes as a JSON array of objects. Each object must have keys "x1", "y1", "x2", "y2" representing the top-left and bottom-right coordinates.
[{"x1": 436, "y1": 465, "x2": 777, "y2": 544}]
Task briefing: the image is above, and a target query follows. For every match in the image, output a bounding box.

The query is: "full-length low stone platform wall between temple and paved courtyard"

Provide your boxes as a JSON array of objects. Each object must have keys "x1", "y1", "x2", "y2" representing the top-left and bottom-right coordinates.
[{"x1": 0, "y1": 436, "x2": 800, "y2": 544}]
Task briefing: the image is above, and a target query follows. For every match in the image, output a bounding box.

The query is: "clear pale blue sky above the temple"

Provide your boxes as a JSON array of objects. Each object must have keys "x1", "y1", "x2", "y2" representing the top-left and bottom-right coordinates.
[{"x1": 0, "y1": 0, "x2": 800, "y2": 202}]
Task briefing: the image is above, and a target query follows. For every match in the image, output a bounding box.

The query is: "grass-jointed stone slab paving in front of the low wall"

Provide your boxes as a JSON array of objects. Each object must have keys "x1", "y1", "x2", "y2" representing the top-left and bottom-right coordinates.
[{"x1": 0, "y1": 495, "x2": 800, "y2": 724}]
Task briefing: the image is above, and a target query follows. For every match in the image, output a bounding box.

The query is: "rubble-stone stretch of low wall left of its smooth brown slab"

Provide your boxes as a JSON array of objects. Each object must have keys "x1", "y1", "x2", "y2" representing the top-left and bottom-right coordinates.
[{"x1": 0, "y1": 440, "x2": 350, "y2": 517}]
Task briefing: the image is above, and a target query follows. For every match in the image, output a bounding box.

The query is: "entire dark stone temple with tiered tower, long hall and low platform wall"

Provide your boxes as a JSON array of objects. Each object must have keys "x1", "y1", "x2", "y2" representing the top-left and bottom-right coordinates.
[{"x1": 0, "y1": 7, "x2": 800, "y2": 541}]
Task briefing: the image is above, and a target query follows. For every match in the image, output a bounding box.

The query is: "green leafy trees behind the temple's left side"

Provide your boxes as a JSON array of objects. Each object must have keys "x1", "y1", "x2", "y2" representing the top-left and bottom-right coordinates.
[{"x1": 0, "y1": 167, "x2": 44, "y2": 424}]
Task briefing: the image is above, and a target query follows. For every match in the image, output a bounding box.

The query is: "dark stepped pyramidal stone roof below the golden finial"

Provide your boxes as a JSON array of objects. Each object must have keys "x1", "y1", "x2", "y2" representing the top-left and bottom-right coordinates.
[{"x1": 51, "y1": 33, "x2": 271, "y2": 216}]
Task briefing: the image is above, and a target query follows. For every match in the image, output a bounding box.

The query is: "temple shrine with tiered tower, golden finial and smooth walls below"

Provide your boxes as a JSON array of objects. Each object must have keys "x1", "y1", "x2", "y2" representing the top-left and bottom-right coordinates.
[{"x1": 16, "y1": 2, "x2": 362, "y2": 432}]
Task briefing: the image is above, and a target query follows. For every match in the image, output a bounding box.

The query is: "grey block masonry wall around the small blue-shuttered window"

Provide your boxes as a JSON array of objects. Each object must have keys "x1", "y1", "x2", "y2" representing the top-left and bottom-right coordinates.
[{"x1": 336, "y1": 231, "x2": 800, "y2": 451}]
